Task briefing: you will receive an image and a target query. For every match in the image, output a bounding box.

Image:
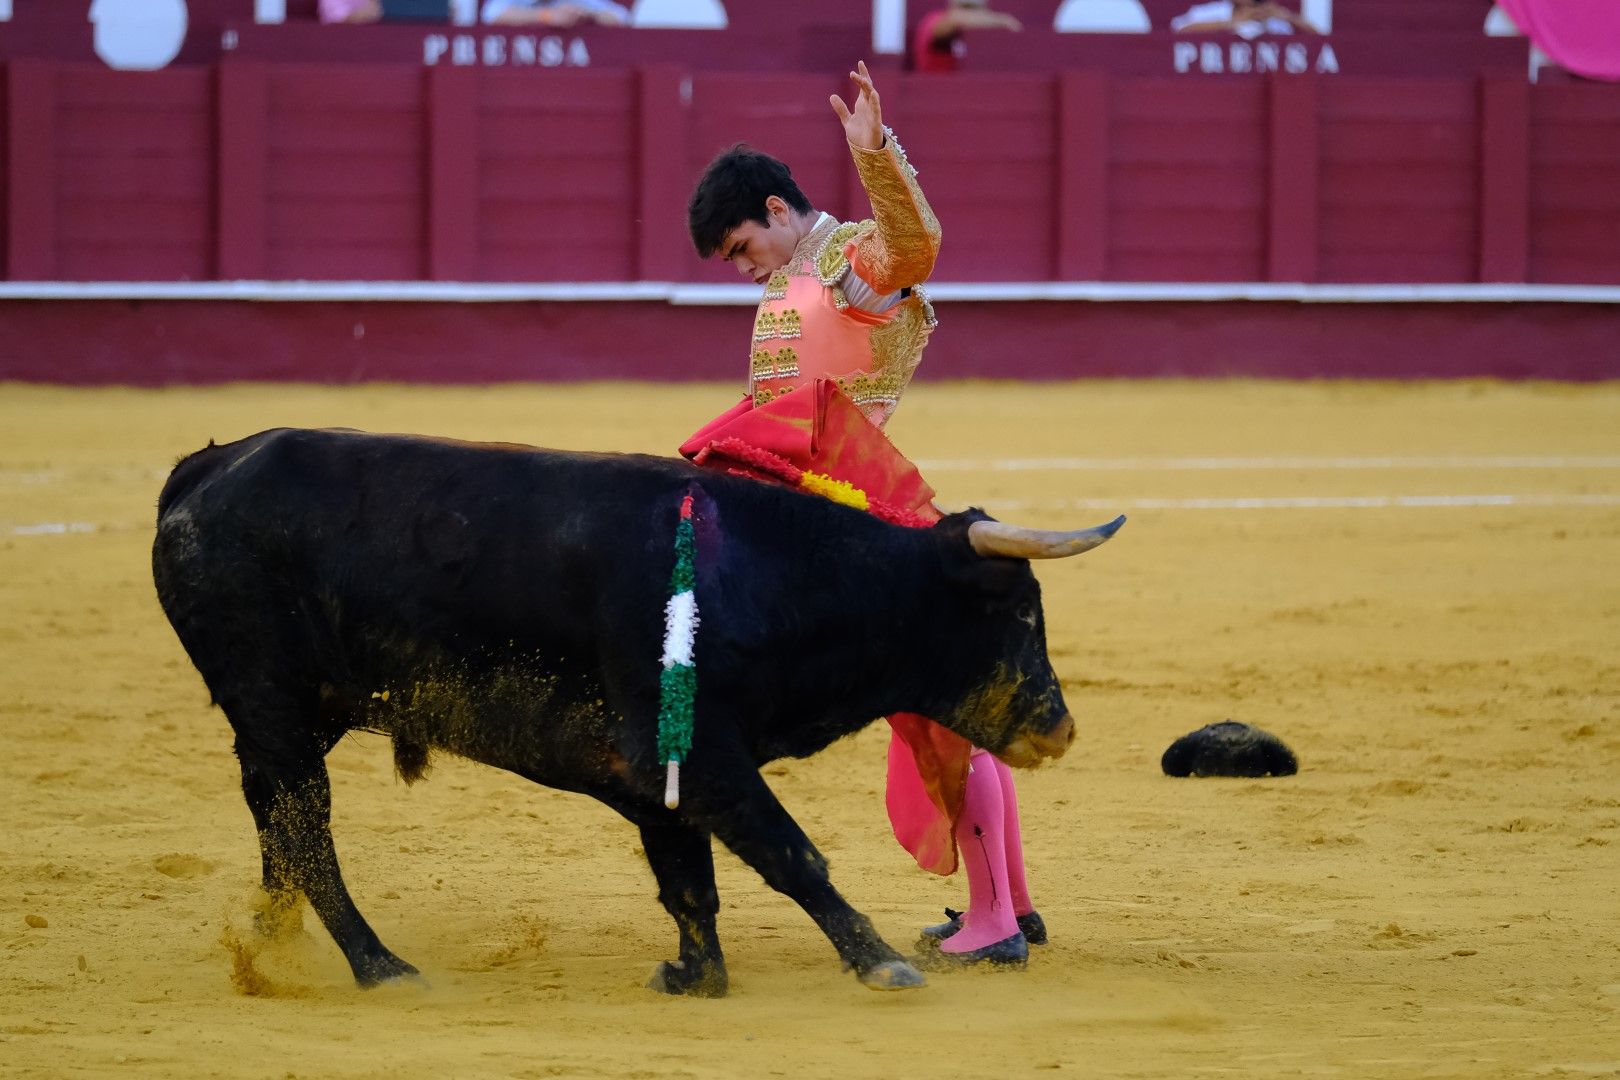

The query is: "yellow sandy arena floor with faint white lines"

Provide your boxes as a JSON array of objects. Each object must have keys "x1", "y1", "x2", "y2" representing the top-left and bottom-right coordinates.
[{"x1": 0, "y1": 382, "x2": 1620, "y2": 1080}]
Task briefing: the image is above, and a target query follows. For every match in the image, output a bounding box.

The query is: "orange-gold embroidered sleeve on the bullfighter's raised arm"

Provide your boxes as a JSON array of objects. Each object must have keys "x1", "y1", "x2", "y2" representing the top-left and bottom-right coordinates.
[{"x1": 851, "y1": 128, "x2": 940, "y2": 293}]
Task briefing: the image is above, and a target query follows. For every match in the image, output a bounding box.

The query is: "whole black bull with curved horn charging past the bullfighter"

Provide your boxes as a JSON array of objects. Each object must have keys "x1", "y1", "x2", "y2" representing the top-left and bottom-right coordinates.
[{"x1": 152, "y1": 429, "x2": 1118, "y2": 994}]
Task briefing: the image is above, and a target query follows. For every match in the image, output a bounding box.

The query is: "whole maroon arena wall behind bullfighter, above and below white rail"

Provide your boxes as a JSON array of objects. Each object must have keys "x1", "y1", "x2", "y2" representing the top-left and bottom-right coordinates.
[{"x1": 0, "y1": 26, "x2": 1620, "y2": 382}]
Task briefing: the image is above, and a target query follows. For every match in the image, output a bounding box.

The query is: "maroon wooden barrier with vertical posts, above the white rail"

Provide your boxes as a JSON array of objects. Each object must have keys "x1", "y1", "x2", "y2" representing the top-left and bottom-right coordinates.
[{"x1": 0, "y1": 60, "x2": 1620, "y2": 283}]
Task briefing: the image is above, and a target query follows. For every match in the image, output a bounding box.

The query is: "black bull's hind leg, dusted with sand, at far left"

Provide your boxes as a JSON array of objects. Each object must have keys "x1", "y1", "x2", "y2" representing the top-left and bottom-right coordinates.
[{"x1": 237, "y1": 729, "x2": 416, "y2": 986}]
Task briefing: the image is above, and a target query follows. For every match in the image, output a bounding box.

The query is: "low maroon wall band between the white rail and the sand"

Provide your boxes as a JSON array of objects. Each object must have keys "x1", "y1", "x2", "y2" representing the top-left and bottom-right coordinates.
[{"x1": 0, "y1": 285, "x2": 1620, "y2": 383}]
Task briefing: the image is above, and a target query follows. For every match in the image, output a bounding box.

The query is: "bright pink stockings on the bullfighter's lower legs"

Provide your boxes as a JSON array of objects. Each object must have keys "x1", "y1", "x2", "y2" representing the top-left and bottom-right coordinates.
[{"x1": 940, "y1": 746, "x2": 1034, "y2": 952}]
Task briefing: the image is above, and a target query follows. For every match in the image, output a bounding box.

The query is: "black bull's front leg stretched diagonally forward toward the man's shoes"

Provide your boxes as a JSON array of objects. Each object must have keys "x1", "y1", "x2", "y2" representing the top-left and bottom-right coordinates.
[{"x1": 696, "y1": 767, "x2": 923, "y2": 989}]
